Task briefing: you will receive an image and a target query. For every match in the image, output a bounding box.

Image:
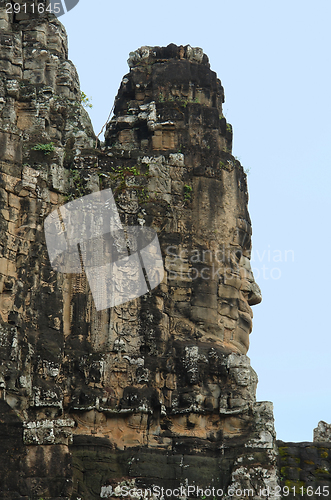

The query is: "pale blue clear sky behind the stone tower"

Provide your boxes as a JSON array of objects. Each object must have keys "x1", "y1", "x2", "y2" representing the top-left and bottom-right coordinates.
[{"x1": 60, "y1": 0, "x2": 331, "y2": 441}]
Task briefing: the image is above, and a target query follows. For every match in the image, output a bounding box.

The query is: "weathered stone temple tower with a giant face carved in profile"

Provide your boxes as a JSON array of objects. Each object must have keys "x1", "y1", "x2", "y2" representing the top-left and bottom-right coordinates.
[{"x1": 0, "y1": 4, "x2": 316, "y2": 500}]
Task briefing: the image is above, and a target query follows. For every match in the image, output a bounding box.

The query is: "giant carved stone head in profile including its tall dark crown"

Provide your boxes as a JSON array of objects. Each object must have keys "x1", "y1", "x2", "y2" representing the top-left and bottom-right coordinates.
[{"x1": 106, "y1": 46, "x2": 261, "y2": 354}]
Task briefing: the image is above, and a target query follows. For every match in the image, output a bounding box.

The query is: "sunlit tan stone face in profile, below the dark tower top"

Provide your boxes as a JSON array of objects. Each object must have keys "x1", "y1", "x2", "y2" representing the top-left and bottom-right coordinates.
[{"x1": 165, "y1": 160, "x2": 261, "y2": 354}]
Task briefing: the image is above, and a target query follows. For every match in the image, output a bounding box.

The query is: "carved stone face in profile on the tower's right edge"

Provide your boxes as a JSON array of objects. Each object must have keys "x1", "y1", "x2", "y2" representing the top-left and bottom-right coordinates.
[{"x1": 192, "y1": 167, "x2": 261, "y2": 354}]
